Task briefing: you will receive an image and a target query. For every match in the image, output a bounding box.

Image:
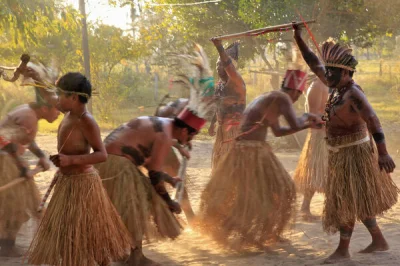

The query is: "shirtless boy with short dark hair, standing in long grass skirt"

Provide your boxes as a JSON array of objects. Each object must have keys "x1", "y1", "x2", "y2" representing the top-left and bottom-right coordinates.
[{"x1": 28, "y1": 73, "x2": 132, "y2": 266}]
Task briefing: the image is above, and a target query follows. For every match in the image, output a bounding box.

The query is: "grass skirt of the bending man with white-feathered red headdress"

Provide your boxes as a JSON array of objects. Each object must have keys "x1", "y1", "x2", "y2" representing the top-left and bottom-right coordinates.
[{"x1": 95, "y1": 154, "x2": 182, "y2": 242}]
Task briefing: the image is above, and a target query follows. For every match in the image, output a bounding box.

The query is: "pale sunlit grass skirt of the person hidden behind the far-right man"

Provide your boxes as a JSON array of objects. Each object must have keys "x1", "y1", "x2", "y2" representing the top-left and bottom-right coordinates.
[{"x1": 293, "y1": 129, "x2": 328, "y2": 193}]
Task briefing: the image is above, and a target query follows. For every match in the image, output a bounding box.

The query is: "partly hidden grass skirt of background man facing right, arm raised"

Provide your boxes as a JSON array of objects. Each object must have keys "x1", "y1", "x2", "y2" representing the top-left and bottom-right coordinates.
[{"x1": 211, "y1": 124, "x2": 240, "y2": 169}]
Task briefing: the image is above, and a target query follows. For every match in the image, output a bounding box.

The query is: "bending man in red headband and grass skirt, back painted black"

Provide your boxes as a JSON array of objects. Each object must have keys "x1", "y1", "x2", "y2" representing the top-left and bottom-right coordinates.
[{"x1": 96, "y1": 108, "x2": 206, "y2": 266}]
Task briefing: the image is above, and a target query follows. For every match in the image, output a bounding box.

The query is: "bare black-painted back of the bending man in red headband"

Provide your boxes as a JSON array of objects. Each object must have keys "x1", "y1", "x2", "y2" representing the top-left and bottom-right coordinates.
[{"x1": 104, "y1": 116, "x2": 172, "y2": 166}]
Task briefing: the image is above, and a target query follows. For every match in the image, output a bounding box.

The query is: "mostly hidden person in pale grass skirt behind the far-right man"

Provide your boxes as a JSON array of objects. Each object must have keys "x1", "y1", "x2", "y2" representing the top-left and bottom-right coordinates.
[{"x1": 293, "y1": 77, "x2": 329, "y2": 221}]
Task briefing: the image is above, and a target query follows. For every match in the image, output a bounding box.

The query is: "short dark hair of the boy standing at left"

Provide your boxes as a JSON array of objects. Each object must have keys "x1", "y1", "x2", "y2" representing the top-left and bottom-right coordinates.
[{"x1": 57, "y1": 72, "x2": 92, "y2": 103}]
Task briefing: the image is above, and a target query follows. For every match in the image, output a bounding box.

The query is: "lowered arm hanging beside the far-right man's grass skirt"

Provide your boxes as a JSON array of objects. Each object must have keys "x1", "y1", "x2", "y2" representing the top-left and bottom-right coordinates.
[{"x1": 349, "y1": 88, "x2": 396, "y2": 173}]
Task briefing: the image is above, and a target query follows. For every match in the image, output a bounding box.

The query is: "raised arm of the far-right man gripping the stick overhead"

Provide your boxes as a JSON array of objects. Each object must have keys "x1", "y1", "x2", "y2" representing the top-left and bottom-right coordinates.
[{"x1": 293, "y1": 24, "x2": 327, "y2": 85}]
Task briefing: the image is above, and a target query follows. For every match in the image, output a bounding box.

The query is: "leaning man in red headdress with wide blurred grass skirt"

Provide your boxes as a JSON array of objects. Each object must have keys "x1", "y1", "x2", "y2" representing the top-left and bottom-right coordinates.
[{"x1": 199, "y1": 70, "x2": 322, "y2": 249}]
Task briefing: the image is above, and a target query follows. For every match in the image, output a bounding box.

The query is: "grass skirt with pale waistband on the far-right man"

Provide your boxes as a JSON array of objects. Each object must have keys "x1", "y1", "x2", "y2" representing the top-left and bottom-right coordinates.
[{"x1": 323, "y1": 132, "x2": 399, "y2": 233}]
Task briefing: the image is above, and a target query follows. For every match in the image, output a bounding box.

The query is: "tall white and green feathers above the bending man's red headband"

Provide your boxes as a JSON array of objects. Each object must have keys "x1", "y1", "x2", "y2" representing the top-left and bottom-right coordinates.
[{"x1": 170, "y1": 43, "x2": 216, "y2": 120}]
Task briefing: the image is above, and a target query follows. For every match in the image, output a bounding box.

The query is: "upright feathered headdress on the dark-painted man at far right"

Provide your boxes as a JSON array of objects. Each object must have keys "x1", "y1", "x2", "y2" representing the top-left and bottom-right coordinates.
[{"x1": 322, "y1": 41, "x2": 358, "y2": 71}]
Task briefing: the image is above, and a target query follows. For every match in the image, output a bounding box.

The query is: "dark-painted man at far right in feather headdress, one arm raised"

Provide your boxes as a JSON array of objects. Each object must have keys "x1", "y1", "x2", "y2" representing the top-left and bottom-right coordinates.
[{"x1": 293, "y1": 21, "x2": 399, "y2": 263}]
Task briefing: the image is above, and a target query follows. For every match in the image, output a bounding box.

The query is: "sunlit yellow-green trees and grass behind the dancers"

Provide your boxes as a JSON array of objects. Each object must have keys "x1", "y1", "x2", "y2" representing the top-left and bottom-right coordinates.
[{"x1": 0, "y1": 0, "x2": 400, "y2": 139}]
